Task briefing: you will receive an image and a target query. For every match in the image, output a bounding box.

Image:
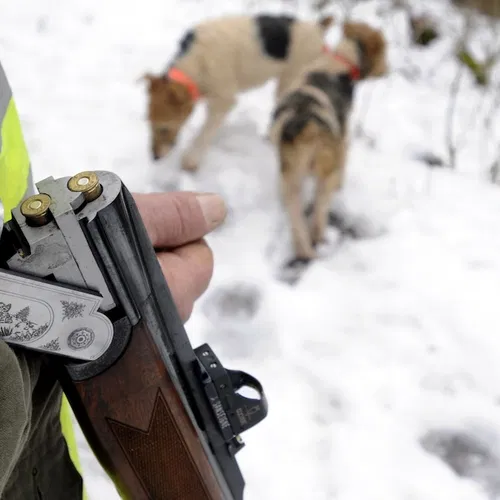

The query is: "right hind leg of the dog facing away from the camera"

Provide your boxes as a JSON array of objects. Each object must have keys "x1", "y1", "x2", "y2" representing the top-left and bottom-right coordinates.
[{"x1": 311, "y1": 143, "x2": 346, "y2": 246}]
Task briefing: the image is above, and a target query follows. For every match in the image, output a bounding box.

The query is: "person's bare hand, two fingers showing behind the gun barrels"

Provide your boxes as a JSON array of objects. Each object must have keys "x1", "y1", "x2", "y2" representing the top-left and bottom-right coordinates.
[{"x1": 133, "y1": 191, "x2": 227, "y2": 322}]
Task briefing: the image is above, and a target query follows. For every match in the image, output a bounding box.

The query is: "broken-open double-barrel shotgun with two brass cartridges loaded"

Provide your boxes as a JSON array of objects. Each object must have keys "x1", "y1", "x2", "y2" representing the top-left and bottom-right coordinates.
[{"x1": 0, "y1": 171, "x2": 267, "y2": 500}]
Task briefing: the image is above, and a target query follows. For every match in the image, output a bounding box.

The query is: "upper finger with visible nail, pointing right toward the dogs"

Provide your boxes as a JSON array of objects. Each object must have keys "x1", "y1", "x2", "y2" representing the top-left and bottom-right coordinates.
[{"x1": 133, "y1": 191, "x2": 227, "y2": 248}]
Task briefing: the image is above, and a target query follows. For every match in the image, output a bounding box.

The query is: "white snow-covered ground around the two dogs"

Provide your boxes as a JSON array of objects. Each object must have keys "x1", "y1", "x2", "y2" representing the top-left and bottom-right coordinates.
[{"x1": 0, "y1": 0, "x2": 500, "y2": 500}]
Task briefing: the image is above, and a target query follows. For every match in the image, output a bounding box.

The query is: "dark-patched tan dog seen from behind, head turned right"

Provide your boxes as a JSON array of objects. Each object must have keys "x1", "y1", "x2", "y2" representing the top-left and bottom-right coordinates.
[{"x1": 269, "y1": 22, "x2": 388, "y2": 266}]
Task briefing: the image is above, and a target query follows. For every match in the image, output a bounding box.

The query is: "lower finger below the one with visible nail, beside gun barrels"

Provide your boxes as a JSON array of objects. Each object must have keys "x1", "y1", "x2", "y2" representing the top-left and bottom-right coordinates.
[{"x1": 158, "y1": 240, "x2": 214, "y2": 322}]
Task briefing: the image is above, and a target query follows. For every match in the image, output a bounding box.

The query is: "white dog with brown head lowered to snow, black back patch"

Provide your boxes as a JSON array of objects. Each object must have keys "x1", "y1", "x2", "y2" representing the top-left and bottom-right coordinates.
[{"x1": 143, "y1": 14, "x2": 333, "y2": 171}]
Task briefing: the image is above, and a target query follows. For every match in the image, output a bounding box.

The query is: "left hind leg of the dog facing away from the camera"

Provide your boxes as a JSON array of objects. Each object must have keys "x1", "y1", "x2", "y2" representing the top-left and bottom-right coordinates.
[{"x1": 280, "y1": 145, "x2": 316, "y2": 261}]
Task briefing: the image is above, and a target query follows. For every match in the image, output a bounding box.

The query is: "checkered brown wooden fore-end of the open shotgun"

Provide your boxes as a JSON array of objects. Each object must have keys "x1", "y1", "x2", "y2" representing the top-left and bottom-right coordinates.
[{"x1": 62, "y1": 321, "x2": 223, "y2": 500}]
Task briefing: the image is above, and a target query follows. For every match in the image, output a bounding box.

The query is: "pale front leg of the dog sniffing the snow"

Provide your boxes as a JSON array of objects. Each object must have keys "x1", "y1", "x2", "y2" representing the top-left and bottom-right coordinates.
[{"x1": 182, "y1": 98, "x2": 236, "y2": 171}]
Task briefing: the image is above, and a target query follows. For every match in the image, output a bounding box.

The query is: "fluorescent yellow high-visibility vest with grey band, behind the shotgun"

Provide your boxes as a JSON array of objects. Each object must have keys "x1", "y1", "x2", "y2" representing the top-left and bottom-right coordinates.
[{"x1": 0, "y1": 63, "x2": 86, "y2": 498}]
